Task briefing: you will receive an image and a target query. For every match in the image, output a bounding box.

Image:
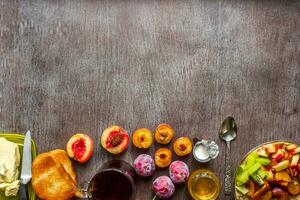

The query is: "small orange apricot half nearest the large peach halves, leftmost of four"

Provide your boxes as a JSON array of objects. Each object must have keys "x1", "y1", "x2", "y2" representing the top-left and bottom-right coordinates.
[{"x1": 132, "y1": 128, "x2": 153, "y2": 149}]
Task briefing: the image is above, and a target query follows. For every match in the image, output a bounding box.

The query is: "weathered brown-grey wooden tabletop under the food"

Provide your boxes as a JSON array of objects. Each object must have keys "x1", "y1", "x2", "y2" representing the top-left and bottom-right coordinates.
[{"x1": 0, "y1": 0, "x2": 300, "y2": 200}]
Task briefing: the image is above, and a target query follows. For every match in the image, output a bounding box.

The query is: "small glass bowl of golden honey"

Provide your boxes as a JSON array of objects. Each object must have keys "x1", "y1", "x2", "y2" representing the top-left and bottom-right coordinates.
[{"x1": 188, "y1": 169, "x2": 220, "y2": 200}]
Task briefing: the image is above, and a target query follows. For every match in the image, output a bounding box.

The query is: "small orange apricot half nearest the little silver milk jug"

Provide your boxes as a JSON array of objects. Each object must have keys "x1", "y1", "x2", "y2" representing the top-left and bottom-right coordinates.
[{"x1": 173, "y1": 137, "x2": 193, "y2": 156}]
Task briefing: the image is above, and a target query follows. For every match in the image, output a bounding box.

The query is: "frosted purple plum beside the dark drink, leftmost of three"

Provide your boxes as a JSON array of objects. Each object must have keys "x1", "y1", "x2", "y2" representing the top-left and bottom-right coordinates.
[{"x1": 133, "y1": 154, "x2": 155, "y2": 177}]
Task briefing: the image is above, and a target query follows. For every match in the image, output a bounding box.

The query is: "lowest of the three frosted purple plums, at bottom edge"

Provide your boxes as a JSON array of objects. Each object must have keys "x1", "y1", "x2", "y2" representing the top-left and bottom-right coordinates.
[{"x1": 152, "y1": 176, "x2": 175, "y2": 199}]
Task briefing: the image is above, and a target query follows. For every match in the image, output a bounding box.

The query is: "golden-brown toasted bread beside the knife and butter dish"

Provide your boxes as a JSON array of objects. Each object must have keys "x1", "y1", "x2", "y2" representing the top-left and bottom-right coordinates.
[{"x1": 32, "y1": 150, "x2": 76, "y2": 200}]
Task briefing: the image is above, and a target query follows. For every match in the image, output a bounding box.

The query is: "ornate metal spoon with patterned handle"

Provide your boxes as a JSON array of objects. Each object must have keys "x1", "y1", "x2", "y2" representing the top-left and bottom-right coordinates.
[{"x1": 219, "y1": 116, "x2": 237, "y2": 195}]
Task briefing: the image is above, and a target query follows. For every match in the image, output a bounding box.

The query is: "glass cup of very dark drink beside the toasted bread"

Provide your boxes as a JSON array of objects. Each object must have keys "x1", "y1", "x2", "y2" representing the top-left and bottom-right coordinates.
[{"x1": 86, "y1": 160, "x2": 136, "y2": 200}]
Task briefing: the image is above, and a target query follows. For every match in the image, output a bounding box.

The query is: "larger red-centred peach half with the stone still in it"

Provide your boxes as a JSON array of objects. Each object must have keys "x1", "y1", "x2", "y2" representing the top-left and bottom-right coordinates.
[{"x1": 100, "y1": 126, "x2": 130, "y2": 154}]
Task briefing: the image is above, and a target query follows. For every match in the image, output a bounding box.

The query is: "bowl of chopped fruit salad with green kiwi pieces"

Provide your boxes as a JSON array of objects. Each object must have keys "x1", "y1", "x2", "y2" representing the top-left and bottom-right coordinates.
[{"x1": 234, "y1": 141, "x2": 300, "y2": 200}]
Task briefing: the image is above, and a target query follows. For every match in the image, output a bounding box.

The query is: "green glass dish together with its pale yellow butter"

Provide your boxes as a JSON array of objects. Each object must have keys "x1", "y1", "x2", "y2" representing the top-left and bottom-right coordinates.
[{"x1": 0, "y1": 133, "x2": 36, "y2": 200}]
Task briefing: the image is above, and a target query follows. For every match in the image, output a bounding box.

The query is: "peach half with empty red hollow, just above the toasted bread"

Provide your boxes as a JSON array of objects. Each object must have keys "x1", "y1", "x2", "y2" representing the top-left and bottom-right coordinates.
[{"x1": 66, "y1": 133, "x2": 94, "y2": 163}]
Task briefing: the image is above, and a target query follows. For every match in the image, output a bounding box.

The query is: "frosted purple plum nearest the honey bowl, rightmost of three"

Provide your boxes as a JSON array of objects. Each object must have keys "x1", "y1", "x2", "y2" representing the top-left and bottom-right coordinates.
[{"x1": 169, "y1": 161, "x2": 190, "y2": 184}]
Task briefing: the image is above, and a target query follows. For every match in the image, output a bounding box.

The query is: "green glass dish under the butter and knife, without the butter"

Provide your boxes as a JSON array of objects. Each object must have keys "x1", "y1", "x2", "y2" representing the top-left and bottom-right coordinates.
[{"x1": 0, "y1": 133, "x2": 36, "y2": 200}]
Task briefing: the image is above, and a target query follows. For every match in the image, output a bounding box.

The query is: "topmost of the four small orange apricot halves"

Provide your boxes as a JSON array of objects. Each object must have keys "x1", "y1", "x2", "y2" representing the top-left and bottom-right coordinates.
[{"x1": 155, "y1": 124, "x2": 174, "y2": 144}]
